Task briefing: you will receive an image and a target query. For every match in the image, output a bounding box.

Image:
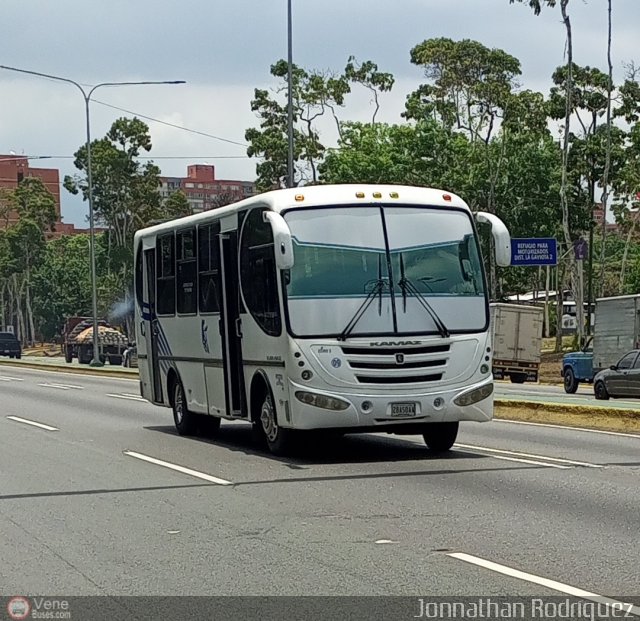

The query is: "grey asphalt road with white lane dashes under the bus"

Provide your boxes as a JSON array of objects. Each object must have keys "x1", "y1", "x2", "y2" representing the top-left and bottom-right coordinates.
[{"x1": 0, "y1": 367, "x2": 640, "y2": 614}]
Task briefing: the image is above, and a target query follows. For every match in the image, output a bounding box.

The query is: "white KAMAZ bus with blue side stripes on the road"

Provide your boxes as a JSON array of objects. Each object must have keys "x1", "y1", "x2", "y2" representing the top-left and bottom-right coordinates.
[{"x1": 134, "y1": 184, "x2": 511, "y2": 454}]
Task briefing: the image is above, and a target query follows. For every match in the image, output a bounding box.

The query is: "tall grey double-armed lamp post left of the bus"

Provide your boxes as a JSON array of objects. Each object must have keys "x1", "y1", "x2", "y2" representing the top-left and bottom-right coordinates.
[{"x1": 0, "y1": 65, "x2": 185, "y2": 367}]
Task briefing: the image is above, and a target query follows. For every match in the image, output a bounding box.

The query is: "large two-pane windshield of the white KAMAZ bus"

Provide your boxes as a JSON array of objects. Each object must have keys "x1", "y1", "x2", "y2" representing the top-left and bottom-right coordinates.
[{"x1": 284, "y1": 205, "x2": 488, "y2": 337}]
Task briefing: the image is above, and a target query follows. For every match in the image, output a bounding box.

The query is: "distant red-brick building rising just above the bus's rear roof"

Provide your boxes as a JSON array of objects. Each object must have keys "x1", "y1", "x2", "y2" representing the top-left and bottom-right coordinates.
[{"x1": 160, "y1": 164, "x2": 256, "y2": 213}]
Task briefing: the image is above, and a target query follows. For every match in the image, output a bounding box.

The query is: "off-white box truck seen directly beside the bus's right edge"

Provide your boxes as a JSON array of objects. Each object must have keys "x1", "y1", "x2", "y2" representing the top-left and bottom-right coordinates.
[{"x1": 489, "y1": 302, "x2": 544, "y2": 384}]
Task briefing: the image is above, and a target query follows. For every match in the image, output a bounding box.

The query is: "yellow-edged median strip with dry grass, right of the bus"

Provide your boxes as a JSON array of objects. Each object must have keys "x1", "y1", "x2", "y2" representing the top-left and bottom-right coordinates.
[{"x1": 494, "y1": 399, "x2": 640, "y2": 434}]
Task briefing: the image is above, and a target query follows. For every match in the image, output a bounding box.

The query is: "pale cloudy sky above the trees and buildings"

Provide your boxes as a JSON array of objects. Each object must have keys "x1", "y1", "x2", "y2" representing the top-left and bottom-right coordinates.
[{"x1": 0, "y1": 0, "x2": 640, "y2": 226}]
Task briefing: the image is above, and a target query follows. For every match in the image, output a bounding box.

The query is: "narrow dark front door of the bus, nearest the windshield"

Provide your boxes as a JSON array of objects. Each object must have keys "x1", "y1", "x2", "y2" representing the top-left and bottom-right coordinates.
[{"x1": 219, "y1": 231, "x2": 246, "y2": 416}]
